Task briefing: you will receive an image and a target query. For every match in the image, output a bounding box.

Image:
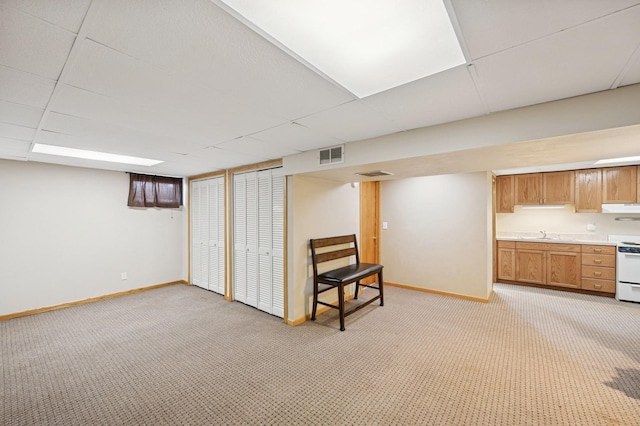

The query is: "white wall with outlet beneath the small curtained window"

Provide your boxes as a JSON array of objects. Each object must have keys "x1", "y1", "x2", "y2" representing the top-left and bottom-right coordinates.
[{"x1": 0, "y1": 160, "x2": 187, "y2": 315}]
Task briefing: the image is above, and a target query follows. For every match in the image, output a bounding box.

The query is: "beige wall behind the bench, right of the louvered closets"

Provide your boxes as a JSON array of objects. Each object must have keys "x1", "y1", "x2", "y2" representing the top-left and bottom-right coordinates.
[{"x1": 287, "y1": 176, "x2": 360, "y2": 322}]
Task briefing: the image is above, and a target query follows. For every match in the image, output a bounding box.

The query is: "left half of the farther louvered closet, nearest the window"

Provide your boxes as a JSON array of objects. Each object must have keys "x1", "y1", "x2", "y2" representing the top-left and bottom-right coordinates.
[{"x1": 191, "y1": 181, "x2": 209, "y2": 289}]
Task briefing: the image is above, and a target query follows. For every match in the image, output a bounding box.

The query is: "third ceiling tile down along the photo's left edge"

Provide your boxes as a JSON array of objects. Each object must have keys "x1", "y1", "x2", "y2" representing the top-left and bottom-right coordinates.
[{"x1": 0, "y1": 65, "x2": 56, "y2": 109}]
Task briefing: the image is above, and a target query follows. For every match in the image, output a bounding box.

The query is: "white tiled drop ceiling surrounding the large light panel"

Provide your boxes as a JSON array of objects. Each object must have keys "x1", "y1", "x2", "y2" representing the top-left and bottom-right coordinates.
[{"x1": 0, "y1": 0, "x2": 640, "y2": 176}]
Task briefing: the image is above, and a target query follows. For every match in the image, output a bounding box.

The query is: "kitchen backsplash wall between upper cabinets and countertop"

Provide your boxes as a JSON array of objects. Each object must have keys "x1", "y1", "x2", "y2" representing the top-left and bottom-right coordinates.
[{"x1": 496, "y1": 206, "x2": 640, "y2": 240}]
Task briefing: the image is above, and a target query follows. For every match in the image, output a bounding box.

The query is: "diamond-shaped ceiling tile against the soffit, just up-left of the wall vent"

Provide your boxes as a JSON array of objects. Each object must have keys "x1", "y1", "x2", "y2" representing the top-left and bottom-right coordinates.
[{"x1": 251, "y1": 123, "x2": 343, "y2": 151}]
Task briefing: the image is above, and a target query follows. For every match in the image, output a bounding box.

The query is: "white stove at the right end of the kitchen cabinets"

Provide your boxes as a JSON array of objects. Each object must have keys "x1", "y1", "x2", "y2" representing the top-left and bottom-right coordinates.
[{"x1": 609, "y1": 235, "x2": 640, "y2": 302}]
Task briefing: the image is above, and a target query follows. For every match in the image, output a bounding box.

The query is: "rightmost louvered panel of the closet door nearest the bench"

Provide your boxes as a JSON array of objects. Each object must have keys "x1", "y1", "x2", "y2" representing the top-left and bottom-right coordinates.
[{"x1": 271, "y1": 168, "x2": 285, "y2": 318}]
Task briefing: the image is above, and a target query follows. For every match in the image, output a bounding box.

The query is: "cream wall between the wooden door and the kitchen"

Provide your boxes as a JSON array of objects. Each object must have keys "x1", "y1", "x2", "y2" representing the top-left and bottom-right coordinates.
[{"x1": 381, "y1": 173, "x2": 492, "y2": 299}]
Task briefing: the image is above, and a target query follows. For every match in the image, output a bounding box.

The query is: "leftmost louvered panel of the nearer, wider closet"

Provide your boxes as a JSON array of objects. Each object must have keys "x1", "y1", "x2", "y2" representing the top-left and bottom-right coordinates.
[{"x1": 233, "y1": 174, "x2": 247, "y2": 303}]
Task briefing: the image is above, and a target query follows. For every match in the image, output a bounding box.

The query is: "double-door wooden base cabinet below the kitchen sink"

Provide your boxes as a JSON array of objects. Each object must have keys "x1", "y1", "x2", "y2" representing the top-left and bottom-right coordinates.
[{"x1": 516, "y1": 242, "x2": 581, "y2": 288}]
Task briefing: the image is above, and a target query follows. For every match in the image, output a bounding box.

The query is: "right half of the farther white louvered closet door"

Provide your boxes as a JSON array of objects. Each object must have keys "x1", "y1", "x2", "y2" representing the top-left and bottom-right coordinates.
[{"x1": 205, "y1": 176, "x2": 224, "y2": 294}]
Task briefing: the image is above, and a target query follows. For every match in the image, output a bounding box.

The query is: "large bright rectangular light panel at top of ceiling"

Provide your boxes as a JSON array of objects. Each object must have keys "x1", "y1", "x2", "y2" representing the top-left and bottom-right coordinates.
[{"x1": 214, "y1": 0, "x2": 466, "y2": 98}]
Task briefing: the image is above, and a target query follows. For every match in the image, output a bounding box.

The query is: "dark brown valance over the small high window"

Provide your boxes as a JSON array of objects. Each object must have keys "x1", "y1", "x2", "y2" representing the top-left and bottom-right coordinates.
[{"x1": 127, "y1": 173, "x2": 182, "y2": 208}]
